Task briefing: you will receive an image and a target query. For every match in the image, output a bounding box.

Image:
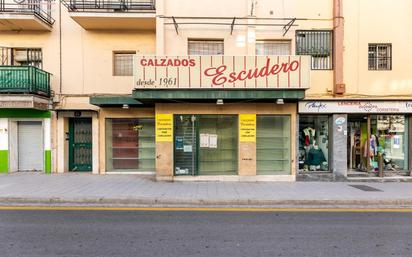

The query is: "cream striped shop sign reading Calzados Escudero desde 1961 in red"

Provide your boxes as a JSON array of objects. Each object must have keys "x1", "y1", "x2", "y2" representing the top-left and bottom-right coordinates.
[{"x1": 133, "y1": 56, "x2": 310, "y2": 89}]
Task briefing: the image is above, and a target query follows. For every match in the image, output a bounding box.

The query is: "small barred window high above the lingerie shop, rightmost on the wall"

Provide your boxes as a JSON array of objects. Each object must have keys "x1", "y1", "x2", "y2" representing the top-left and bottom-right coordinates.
[{"x1": 368, "y1": 44, "x2": 392, "y2": 70}]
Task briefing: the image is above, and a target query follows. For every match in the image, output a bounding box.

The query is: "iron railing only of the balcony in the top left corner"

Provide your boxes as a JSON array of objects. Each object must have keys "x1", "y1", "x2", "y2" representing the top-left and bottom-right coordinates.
[{"x1": 0, "y1": 0, "x2": 55, "y2": 26}]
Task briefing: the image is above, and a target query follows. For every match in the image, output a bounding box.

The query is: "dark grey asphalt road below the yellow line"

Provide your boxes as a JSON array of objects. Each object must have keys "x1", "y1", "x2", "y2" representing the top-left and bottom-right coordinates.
[{"x1": 0, "y1": 210, "x2": 412, "y2": 257}]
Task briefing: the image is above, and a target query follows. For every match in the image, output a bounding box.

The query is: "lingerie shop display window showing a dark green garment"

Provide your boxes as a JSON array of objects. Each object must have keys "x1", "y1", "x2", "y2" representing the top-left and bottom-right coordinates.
[{"x1": 299, "y1": 115, "x2": 330, "y2": 172}]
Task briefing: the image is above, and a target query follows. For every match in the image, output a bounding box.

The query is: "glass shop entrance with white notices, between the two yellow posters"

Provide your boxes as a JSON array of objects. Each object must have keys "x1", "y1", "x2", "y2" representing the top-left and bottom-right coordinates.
[{"x1": 174, "y1": 115, "x2": 238, "y2": 176}]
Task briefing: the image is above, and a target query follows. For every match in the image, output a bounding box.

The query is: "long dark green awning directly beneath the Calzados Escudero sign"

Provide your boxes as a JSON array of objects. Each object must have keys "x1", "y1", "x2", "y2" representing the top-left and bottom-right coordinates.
[{"x1": 133, "y1": 89, "x2": 305, "y2": 102}]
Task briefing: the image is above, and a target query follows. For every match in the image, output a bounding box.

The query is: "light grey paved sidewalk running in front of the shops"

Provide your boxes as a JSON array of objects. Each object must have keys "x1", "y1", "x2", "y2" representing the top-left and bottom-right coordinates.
[{"x1": 0, "y1": 173, "x2": 412, "y2": 206}]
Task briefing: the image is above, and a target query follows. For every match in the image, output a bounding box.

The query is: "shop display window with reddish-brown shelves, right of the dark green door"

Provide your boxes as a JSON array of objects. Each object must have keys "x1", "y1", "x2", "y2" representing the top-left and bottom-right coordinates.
[{"x1": 106, "y1": 118, "x2": 156, "y2": 172}]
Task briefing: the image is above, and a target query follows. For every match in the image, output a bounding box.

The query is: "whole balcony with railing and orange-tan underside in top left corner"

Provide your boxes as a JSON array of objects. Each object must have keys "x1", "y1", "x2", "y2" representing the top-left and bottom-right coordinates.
[{"x1": 0, "y1": 0, "x2": 55, "y2": 31}]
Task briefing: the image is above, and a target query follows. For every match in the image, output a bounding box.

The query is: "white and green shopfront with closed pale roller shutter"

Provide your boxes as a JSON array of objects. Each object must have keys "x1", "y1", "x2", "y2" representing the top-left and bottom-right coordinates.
[{"x1": 0, "y1": 109, "x2": 52, "y2": 173}]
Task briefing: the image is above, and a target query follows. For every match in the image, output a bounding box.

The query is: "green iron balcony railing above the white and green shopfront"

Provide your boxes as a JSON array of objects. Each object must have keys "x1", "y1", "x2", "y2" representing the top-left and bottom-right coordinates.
[{"x1": 0, "y1": 66, "x2": 50, "y2": 97}]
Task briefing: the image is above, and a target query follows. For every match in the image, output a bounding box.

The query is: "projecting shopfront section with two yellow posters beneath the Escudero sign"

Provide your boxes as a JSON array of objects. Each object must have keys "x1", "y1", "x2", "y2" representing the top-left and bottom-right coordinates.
[{"x1": 155, "y1": 103, "x2": 296, "y2": 180}]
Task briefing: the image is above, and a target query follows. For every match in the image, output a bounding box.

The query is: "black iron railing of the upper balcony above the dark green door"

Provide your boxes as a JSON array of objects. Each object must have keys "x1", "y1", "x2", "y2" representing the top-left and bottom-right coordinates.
[{"x1": 62, "y1": 0, "x2": 156, "y2": 12}]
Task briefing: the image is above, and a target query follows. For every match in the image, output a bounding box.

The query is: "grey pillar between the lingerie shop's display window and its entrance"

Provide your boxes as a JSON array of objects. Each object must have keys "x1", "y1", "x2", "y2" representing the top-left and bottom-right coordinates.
[{"x1": 330, "y1": 114, "x2": 348, "y2": 177}]
